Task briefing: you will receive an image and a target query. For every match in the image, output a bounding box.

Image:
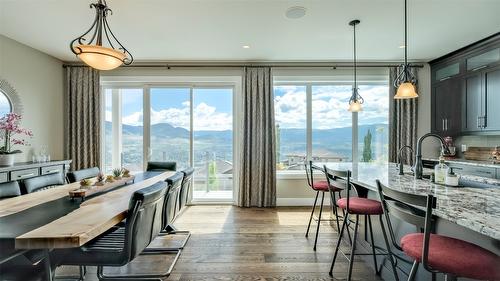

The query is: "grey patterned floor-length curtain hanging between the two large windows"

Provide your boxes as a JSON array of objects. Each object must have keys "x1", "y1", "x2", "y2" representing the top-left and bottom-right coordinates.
[{"x1": 238, "y1": 67, "x2": 276, "y2": 207}]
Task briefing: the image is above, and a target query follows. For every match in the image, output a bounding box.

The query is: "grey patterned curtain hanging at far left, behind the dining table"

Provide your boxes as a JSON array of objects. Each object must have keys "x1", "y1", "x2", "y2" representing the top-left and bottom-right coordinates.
[{"x1": 65, "y1": 66, "x2": 101, "y2": 170}]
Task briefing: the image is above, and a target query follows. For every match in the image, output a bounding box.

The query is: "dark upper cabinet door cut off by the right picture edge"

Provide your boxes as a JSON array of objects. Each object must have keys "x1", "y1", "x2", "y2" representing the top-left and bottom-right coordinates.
[{"x1": 484, "y1": 68, "x2": 500, "y2": 131}]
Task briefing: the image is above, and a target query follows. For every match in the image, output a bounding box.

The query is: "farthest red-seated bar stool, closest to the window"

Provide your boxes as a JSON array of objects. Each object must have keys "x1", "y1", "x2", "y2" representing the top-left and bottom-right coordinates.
[{"x1": 305, "y1": 161, "x2": 342, "y2": 251}]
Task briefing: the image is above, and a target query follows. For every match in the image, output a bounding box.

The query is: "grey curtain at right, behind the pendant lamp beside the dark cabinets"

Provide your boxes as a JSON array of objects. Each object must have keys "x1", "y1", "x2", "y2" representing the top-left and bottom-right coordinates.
[{"x1": 389, "y1": 67, "x2": 419, "y2": 165}]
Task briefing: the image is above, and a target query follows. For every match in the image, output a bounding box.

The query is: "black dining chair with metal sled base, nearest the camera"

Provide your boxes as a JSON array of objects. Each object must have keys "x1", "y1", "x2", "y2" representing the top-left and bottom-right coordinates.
[{"x1": 55, "y1": 182, "x2": 181, "y2": 280}]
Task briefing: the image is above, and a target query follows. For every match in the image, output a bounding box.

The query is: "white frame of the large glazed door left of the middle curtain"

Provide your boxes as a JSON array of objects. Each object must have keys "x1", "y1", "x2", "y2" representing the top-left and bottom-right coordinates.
[{"x1": 100, "y1": 76, "x2": 242, "y2": 204}]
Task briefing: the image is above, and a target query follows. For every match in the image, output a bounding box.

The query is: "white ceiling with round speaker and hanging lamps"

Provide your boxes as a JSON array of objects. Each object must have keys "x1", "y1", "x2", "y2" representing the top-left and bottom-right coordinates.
[{"x1": 0, "y1": 0, "x2": 500, "y2": 61}]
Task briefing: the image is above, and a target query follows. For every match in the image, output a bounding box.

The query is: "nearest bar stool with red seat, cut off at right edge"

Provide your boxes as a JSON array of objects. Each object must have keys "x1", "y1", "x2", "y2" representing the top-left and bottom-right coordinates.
[{"x1": 377, "y1": 180, "x2": 500, "y2": 280}]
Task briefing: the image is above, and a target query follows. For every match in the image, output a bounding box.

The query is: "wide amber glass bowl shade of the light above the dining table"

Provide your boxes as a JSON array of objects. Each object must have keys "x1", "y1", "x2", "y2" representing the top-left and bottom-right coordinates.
[{"x1": 75, "y1": 45, "x2": 126, "y2": 70}]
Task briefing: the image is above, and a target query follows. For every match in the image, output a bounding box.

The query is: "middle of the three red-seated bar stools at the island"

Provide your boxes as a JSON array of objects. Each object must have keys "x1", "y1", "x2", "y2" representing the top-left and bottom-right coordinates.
[{"x1": 325, "y1": 166, "x2": 397, "y2": 281}]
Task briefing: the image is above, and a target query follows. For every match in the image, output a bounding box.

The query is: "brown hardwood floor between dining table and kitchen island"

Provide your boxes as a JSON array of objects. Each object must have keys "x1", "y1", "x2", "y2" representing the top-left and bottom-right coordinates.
[{"x1": 56, "y1": 206, "x2": 381, "y2": 280}]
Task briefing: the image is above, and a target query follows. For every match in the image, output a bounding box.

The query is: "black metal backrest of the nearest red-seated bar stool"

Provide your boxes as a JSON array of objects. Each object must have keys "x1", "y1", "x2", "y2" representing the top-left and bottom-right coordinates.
[{"x1": 376, "y1": 180, "x2": 437, "y2": 269}]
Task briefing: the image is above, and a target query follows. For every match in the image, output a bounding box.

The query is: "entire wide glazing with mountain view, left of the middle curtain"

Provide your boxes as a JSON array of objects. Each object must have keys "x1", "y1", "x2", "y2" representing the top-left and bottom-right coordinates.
[{"x1": 102, "y1": 85, "x2": 234, "y2": 201}]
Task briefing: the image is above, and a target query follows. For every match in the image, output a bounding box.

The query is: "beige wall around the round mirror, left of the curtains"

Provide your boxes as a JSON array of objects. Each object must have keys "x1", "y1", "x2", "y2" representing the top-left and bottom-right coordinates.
[{"x1": 0, "y1": 35, "x2": 64, "y2": 161}]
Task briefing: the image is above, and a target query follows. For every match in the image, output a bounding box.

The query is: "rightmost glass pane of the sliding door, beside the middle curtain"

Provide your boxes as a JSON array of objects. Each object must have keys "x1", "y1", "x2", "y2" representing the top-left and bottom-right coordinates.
[{"x1": 192, "y1": 88, "x2": 233, "y2": 200}]
